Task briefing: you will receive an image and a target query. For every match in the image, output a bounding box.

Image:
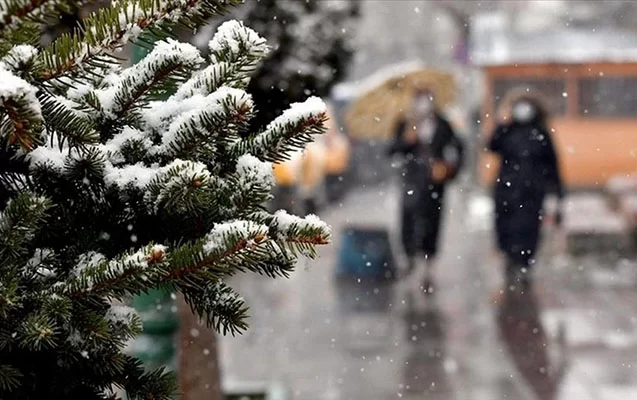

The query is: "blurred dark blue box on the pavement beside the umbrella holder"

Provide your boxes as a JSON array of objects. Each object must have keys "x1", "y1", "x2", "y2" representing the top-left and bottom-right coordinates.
[{"x1": 336, "y1": 227, "x2": 395, "y2": 279}]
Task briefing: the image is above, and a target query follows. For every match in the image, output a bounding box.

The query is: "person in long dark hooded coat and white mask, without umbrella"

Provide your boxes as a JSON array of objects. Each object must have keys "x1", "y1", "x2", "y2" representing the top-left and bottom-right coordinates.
[{"x1": 489, "y1": 95, "x2": 564, "y2": 283}]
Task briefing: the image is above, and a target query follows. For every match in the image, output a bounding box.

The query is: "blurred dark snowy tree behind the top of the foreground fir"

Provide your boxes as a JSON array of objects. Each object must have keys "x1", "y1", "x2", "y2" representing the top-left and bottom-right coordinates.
[{"x1": 195, "y1": 0, "x2": 360, "y2": 126}]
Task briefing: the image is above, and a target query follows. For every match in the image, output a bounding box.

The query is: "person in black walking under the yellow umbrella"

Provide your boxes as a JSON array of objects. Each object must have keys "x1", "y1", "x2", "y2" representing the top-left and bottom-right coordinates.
[{"x1": 389, "y1": 88, "x2": 463, "y2": 293}]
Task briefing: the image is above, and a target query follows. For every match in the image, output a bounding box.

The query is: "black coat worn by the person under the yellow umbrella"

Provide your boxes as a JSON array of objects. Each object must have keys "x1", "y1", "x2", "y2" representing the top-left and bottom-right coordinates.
[{"x1": 389, "y1": 115, "x2": 463, "y2": 257}]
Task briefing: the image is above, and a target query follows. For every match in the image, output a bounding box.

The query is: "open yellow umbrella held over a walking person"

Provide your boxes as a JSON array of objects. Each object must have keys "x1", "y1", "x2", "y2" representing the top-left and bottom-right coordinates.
[{"x1": 345, "y1": 69, "x2": 455, "y2": 139}]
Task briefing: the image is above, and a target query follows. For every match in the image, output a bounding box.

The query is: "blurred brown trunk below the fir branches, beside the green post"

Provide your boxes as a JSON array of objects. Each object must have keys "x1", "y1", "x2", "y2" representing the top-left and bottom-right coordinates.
[{"x1": 178, "y1": 298, "x2": 223, "y2": 400}]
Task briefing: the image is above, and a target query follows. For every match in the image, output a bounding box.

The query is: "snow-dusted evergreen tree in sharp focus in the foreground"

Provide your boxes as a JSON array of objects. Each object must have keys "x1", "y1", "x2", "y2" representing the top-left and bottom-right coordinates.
[{"x1": 0, "y1": 0, "x2": 330, "y2": 400}]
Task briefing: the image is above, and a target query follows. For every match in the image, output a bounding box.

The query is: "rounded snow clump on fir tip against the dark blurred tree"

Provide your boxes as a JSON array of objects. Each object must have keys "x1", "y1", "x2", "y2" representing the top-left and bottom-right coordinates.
[{"x1": 208, "y1": 20, "x2": 268, "y2": 62}]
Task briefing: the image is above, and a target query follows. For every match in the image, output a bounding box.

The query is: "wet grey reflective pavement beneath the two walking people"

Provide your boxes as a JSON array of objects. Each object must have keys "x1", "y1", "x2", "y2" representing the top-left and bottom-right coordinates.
[{"x1": 221, "y1": 184, "x2": 637, "y2": 400}]
